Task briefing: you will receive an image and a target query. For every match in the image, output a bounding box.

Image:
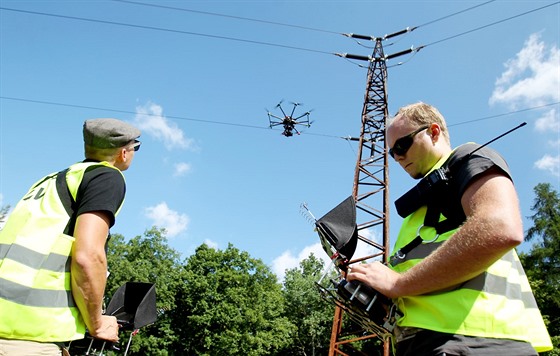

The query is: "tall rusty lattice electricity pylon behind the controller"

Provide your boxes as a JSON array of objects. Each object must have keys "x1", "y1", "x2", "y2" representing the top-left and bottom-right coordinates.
[{"x1": 329, "y1": 28, "x2": 420, "y2": 356}]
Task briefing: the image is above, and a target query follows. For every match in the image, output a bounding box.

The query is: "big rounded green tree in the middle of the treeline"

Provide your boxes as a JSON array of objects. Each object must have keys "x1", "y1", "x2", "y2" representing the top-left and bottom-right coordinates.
[{"x1": 172, "y1": 244, "x2": 294, "y2": 356}]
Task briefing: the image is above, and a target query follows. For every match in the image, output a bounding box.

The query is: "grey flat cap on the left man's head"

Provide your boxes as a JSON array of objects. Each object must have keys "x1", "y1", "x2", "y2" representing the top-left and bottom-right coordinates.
[{"x1": 84, "y1": 119, "x2": 140, "y2": 148}]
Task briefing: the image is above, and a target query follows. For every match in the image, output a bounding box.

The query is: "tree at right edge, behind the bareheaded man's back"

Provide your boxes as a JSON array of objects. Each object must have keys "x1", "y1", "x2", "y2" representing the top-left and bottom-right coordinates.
[{"x1": 520, "y1": 183, "x2": 560, "y2": 356}]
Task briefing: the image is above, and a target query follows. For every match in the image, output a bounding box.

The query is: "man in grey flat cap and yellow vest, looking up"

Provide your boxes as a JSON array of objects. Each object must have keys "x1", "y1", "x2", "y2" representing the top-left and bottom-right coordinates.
[{"x1": 0, "y1": 119, "x2": 140, "y2": 356}]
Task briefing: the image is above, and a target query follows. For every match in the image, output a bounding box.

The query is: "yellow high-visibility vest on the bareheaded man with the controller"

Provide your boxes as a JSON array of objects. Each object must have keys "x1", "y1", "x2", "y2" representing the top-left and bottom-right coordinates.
[{"x1": 391, "y1": 152, "x2": 552, "y2": 352}]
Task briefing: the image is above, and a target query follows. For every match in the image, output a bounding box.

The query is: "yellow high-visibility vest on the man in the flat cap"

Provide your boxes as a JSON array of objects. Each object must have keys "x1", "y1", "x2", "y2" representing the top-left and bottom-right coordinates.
[{"x1": 0, "y1": 162, "x2": 120, "y2": 342}]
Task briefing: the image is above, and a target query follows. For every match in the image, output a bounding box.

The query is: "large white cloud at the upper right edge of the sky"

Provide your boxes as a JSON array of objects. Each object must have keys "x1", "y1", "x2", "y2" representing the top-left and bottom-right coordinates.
[{"x1": 490, "y1": 33, "x2": 560, "y2": 108}]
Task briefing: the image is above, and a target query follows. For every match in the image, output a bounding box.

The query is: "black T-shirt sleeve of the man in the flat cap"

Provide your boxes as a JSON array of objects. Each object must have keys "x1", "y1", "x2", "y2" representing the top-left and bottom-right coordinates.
[{"x1": 76, "y1": 161, "x2": 126, "y2": 227}]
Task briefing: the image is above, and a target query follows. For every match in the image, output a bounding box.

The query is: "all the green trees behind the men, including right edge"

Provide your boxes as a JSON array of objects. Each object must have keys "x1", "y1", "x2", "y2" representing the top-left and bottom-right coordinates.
[{"x1": 0, "y1": 184, "x2": 560, "y2": 356}]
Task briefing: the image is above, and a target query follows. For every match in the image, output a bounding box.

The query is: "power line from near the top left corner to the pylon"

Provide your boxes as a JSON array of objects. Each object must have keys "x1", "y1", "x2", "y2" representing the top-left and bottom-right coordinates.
[{"x1": 0, "y1": 7, "x2": 333, "y2": 55}]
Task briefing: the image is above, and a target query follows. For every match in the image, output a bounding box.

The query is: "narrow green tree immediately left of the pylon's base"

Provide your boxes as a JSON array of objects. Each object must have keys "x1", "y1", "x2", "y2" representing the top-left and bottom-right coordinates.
[{"x1": 283, "y1": 254, "x2": 334, "y2": 355}]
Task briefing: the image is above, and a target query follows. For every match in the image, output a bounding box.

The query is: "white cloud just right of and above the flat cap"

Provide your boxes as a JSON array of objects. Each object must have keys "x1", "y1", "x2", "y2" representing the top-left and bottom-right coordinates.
[{"x1": 134, "y1": 102, "x2": 195, "y2": 150}]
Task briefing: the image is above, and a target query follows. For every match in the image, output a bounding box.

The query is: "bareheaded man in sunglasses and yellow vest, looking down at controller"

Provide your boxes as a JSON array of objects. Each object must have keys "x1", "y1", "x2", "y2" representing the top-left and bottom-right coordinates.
[{"x1": 347, "y1": 103, "x2": 552, "y2": 356}]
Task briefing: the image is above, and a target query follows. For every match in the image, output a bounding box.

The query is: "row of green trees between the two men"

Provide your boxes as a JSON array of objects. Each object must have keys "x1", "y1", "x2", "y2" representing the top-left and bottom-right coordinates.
[{"x1": 102, "y1": 228, "x2": 366, "y2": 356}]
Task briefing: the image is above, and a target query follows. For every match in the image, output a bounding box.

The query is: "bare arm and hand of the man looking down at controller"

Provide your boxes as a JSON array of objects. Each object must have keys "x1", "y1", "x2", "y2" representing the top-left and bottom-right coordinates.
[{"x1": 347, "y1": 172, "x2": 523, "y2": 298}]
